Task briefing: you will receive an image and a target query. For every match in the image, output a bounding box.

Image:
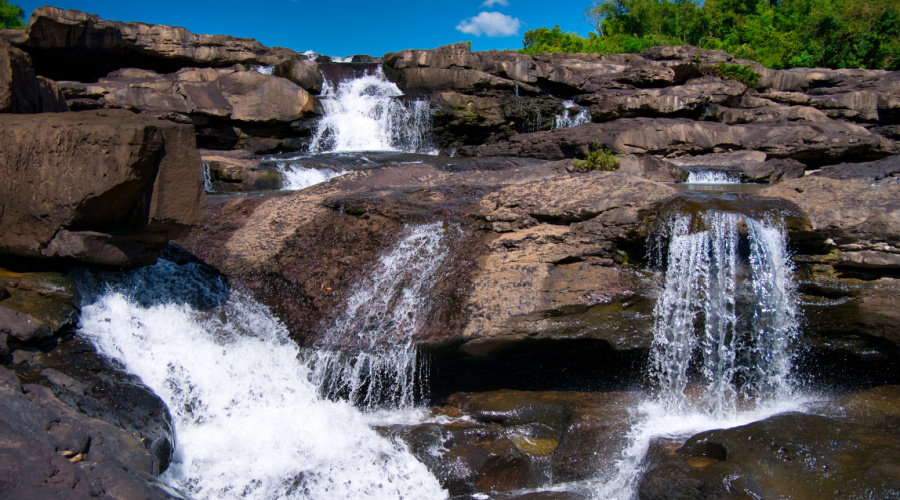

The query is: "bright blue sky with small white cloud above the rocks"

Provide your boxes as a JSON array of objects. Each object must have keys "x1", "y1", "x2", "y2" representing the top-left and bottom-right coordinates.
[{"x1": 17, "y1": 0, "x2": 593, "y2": 56}]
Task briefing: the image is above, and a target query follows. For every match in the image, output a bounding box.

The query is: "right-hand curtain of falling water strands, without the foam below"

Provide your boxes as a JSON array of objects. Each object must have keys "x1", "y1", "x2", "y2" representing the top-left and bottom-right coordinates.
[{"x1": 651, "y1": 211, "x2": 798, "y2": 415}]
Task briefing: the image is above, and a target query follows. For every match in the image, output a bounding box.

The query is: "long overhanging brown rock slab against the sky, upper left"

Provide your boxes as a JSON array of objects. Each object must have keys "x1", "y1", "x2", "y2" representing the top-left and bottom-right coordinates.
[{"x1": 19, "y1": 7, "x2": 300, "y2": 82}]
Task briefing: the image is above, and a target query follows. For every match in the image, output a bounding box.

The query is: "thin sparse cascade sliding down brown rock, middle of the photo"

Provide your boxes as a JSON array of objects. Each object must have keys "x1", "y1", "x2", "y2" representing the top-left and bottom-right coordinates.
[{"x1": 310, "y1": 222, "x2": 447, "y2": 410}]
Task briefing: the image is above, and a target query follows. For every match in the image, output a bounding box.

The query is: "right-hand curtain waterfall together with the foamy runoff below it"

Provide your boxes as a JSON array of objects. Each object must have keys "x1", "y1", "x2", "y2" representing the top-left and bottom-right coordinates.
[{"x1": 597, "y1": 211, "x2": 806, "y2": 500}]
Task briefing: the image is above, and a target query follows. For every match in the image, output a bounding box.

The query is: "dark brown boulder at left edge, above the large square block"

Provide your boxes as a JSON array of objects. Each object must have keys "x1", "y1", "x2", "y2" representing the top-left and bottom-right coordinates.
[{"x1": 0, "y1": 40, "x2": 68, "y2": 113}]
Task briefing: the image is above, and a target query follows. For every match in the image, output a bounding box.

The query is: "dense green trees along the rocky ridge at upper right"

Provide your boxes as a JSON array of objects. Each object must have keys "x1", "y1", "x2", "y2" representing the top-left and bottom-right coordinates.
[{"x1": 523, "y1": 0, "x2": 900, "y2": 70}]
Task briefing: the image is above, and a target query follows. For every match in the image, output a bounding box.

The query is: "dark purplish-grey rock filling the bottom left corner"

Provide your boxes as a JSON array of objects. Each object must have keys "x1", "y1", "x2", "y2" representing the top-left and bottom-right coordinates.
[{"x1": 0, "y1": 368, "x2": 180, "y2": 500}]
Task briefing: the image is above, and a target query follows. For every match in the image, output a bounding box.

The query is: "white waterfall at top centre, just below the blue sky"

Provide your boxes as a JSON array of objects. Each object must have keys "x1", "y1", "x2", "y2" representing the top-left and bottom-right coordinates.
[{"x1": 309, "y1": 66, "x2": 431, "y2": 153}]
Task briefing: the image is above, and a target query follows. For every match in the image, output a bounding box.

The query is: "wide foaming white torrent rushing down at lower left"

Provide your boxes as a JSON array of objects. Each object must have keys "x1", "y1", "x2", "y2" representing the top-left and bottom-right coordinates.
[{"x1": 79, "y1": 261, "x2": 446, "y2": 500}]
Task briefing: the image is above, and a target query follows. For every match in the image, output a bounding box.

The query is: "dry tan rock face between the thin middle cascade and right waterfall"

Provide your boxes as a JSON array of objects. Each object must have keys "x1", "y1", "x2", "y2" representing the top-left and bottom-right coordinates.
[{"x1": 462, "y1": 172, "x2": 677, "y2": 355}]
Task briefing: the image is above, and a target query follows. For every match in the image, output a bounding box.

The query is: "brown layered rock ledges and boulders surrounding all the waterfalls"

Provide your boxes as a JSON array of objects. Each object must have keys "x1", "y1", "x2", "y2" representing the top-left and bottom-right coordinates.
[{"x1": 0, "y1": 7, "x2": 900, "y2": 499}]
